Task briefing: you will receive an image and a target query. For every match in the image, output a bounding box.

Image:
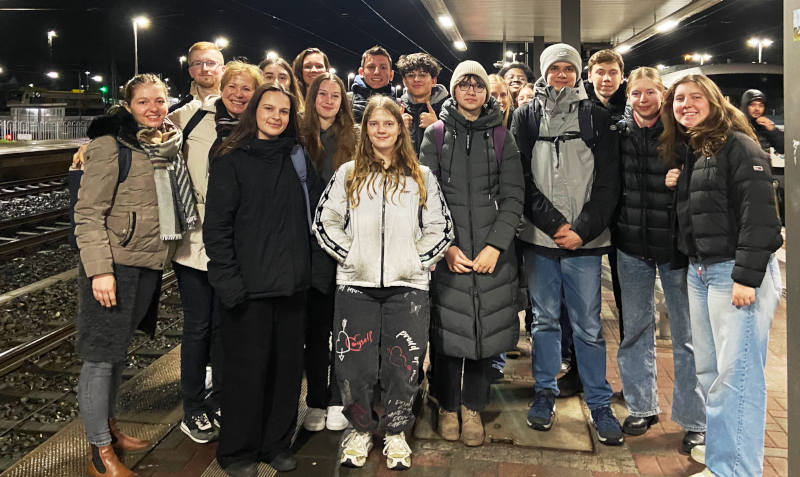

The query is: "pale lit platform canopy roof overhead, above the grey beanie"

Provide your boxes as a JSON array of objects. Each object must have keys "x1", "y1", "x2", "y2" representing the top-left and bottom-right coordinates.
[{"x1": 421, "y1": 0, "x2": 722, "y2": 46}]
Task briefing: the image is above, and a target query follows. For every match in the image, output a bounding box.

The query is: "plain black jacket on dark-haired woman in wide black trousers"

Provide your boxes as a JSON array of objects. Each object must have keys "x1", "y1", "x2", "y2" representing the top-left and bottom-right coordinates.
[{"x1": 203, "y1": 137, "x2": 322, "y2": 308}]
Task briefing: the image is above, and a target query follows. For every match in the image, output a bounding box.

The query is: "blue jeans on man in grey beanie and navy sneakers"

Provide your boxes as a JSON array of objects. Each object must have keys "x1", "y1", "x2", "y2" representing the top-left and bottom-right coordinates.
[{"x1": 524, "y1": 246, "x2": 612, "y2": 410}]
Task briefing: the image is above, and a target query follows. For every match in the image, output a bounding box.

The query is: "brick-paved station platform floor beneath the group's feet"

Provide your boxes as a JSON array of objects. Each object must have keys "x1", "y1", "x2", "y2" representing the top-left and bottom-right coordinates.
[{"x1": 2, "y1": 274, "x2": 788, "y2": 477}]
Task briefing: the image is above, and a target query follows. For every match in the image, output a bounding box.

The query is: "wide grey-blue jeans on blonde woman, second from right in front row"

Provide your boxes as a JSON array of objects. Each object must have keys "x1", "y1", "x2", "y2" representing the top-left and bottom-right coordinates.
[{"x1": 617, "y1": 249, "x2": 706, "y2": 432}]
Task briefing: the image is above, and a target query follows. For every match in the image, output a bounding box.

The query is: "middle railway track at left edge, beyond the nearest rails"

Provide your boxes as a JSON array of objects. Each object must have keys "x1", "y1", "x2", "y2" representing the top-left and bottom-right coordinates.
[{"x1": 0, "y1": 207, "x2": 71, "y2": 256}]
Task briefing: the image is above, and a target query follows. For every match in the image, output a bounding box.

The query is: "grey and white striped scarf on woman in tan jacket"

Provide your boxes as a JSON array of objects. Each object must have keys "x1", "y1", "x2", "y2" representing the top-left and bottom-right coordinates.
[{"x1": 136, "y1": 121, "x2": 198, "y2": 240}]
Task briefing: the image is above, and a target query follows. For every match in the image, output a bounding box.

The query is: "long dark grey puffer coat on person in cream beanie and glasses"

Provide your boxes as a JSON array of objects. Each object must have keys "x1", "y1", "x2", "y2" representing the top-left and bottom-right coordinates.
[{"x1": 420, "y1": 98, "x2": 524, "y2": 359}]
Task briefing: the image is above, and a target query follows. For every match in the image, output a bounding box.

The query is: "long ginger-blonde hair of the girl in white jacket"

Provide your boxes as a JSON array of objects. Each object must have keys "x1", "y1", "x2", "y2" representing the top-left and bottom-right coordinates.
[{"x1": 345, "y1": 95, "x2": 427, "y2": 208}]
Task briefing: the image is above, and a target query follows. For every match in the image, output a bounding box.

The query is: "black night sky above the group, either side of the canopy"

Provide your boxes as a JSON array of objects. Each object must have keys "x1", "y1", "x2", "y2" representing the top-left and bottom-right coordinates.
[{"x1": 0, "y1": 0, "x2": 783, "y2": 98}]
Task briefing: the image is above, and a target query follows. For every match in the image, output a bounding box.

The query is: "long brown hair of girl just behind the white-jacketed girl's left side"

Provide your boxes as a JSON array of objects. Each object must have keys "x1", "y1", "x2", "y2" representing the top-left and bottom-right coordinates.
[{"x1": 298, "y1": 73, "x2": 357, "y2": 170}]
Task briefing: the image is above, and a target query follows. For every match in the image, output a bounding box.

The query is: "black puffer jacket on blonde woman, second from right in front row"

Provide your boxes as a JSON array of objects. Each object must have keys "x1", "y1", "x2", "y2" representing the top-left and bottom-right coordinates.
[{"x1": 611, "y1": 115, "x2": 675, "y2": 264}]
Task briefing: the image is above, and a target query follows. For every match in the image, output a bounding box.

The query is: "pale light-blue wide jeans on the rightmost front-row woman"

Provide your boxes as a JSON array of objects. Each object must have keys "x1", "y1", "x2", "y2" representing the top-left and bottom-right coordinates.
[{"x1": 688, "y1": 255, "x2": 781, "y2": 477}]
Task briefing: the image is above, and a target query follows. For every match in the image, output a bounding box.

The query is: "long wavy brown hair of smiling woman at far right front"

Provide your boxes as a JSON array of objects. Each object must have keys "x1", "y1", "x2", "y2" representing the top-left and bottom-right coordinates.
[{"x1": 658, "y1": 75, "x2": 758, "y2": 167}]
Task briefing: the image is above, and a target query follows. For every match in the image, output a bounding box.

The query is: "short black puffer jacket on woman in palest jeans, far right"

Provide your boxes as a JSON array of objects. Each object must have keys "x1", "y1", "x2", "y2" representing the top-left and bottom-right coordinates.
[{"x1": 677, "y1": 132, "x2": 783, "y2": 287}]
